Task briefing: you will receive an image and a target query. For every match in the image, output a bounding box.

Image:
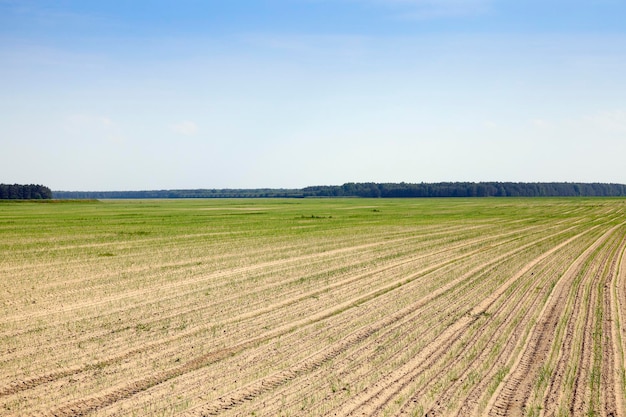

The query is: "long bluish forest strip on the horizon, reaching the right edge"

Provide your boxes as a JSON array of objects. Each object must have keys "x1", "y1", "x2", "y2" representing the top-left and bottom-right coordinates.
[{"x1": 53, "y1": 182, "x2": 626, "y2": 199}]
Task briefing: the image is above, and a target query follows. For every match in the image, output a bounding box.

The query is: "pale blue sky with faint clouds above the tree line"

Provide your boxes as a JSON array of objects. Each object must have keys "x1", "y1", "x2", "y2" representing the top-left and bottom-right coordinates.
[{"x1": 0, "y1": 0, "x2": 626, "y2": 191}]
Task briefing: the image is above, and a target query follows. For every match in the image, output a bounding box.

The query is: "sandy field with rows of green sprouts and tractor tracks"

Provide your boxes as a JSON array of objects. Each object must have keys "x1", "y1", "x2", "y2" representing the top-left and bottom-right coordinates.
[{"x1": 0, "y1": 198, "x2": 626, "y2": 416}]
